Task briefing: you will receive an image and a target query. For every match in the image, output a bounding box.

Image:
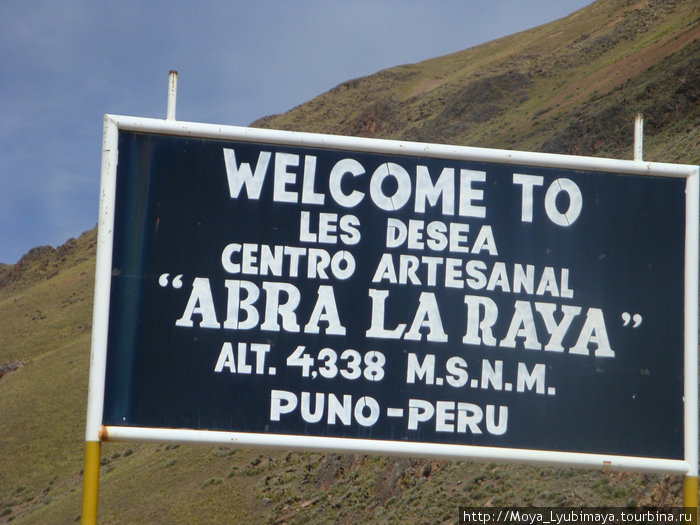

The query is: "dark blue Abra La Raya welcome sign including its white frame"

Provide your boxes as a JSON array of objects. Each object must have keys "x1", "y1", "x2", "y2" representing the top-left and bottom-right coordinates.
[{"x1": 85, "y1": 117, "x2": 697, "y2": 471}]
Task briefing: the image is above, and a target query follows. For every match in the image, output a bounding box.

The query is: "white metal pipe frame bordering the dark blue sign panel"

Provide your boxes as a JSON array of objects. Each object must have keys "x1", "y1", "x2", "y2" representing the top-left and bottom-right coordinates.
[{"x1": 86, "y1": 115, "x2": 700, "y2": 476}]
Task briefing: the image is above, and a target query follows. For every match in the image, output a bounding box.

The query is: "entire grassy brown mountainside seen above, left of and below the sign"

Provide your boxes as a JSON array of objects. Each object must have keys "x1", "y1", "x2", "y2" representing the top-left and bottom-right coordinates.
[{"x1": 0, "y1": 0, "x2": 700, "y2": 523}]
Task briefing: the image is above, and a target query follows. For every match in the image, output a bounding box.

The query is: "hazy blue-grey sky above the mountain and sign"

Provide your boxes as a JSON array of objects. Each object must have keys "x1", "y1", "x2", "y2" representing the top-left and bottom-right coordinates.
[{"x1": 0, "y1": 0, "x2": 591, "y2": 264}]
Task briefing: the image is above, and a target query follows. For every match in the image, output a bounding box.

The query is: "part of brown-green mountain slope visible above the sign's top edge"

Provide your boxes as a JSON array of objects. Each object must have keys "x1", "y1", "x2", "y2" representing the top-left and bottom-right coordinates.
[{"x1": 253, "y1": 0, "x2": 700, "y2": 164}]
